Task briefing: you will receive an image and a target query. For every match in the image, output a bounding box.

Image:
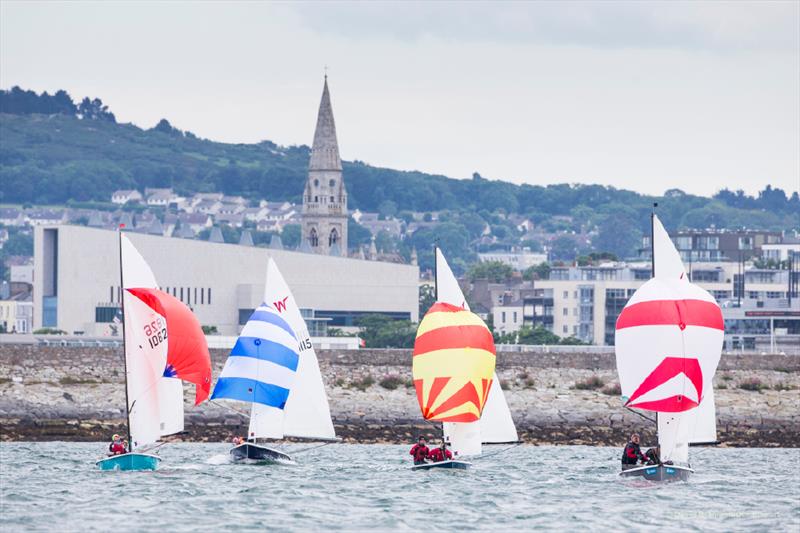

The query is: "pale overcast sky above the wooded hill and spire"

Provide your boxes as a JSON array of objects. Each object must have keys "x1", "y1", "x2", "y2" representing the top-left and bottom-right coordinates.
[{"x1": 0, "y1": 0, "x2": 800, "y2": 195}]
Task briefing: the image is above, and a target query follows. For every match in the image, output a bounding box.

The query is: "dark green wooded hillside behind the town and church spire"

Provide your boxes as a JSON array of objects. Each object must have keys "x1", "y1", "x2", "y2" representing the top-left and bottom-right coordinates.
[{"x1": 0, "y1": 88, "x2": 800, "y2": 266}]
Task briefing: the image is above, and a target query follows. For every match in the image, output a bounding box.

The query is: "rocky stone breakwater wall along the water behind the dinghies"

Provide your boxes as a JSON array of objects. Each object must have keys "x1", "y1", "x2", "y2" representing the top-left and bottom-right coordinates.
[{"x1": 0, "y1": 344, "x2": 800, "y2": 447}]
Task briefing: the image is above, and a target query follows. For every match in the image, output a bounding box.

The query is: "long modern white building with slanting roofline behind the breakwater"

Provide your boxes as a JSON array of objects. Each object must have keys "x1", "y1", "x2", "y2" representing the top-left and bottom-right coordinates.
[{"x1": 33, "y1": 225, "x2": 419, "y2": 336}]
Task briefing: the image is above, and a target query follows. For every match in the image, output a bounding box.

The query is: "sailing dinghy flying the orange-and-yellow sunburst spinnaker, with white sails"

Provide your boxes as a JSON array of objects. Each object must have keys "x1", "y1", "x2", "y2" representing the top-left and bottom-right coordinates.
[{"x1": 412, "y1": 247, "x2": 519, "y2": 470}]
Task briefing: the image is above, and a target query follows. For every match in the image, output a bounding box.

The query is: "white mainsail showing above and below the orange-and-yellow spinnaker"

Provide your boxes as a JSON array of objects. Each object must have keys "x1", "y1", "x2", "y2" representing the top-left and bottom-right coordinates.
[{"x1": 436, "y1": 247, "x2": 519, "y2": 456}]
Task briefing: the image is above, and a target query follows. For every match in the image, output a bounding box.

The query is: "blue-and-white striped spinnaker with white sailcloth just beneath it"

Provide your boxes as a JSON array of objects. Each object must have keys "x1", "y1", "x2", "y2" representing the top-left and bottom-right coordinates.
[{"x1": 211, "y1": 303, "x2": 300, "y2": 438}]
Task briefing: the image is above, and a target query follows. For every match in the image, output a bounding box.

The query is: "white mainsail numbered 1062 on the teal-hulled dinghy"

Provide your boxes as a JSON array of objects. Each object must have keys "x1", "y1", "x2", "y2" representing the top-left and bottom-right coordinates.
[{"x1": 120, "y1": 234, "x2": 167, "y2": 450}]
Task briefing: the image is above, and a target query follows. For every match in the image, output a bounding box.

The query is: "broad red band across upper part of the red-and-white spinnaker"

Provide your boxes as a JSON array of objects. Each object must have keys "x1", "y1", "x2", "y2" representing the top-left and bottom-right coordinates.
[{"x1": 617, "y1": 300, "x2": 725, "y2": 330}]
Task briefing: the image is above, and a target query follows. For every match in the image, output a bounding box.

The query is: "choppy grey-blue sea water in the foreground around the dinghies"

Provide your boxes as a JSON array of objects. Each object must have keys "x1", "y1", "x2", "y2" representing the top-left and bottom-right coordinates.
[{"x1": 0, "y1": 443, "x2": 800, "y2": 531}]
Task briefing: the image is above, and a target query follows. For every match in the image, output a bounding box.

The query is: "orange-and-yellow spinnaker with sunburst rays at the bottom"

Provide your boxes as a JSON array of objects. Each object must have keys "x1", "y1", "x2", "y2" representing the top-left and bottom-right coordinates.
[{"x1": 412, "y1": 302, "x2": 495, "y2": 422}]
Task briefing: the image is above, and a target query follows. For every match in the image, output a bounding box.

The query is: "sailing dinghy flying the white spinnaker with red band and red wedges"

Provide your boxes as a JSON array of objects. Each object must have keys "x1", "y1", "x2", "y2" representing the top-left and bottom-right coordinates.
[{"x1": 615, "y1": 213, "x2": 724, "y2": 481}]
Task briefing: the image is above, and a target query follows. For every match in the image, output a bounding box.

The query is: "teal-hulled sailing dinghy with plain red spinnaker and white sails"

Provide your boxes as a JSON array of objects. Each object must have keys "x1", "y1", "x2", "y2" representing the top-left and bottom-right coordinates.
[{"x1": 96, "y1": 229, "x2": 211, "y2": 470}]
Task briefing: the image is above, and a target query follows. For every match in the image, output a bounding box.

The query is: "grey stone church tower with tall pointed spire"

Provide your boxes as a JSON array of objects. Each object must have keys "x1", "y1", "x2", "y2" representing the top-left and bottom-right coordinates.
[{"x1": 303, "y1": 75, "x2": 347, "y2": 257}]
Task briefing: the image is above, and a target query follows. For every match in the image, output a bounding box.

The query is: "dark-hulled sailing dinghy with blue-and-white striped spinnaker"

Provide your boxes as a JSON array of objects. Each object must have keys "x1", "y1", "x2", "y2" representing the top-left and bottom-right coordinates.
[{"x1": 211, "y1": 258, "x2": 338, "y2": 463}]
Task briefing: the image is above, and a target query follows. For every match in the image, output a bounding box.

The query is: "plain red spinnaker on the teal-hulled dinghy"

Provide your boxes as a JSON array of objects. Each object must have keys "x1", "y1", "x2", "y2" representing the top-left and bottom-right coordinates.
[{"x1": 127, "y1": 288, "x2": 211, "y2": 405}]
